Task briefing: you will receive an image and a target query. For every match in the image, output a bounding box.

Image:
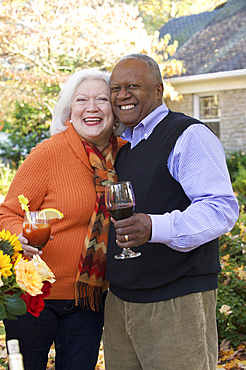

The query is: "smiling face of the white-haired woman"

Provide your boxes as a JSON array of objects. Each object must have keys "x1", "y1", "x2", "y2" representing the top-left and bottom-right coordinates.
[{"x1": 71, "y1": 80, "x2": 114, "y2": 150}]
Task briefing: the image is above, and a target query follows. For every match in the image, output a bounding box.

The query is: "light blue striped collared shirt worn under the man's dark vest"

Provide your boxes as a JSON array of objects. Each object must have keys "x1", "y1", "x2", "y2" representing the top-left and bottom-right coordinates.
[{"x1": 122, "y1": 104, "x2": 239, "y2": 252}]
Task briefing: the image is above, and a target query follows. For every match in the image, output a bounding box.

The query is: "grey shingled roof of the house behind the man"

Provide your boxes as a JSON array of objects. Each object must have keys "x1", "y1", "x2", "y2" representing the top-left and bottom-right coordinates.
[{"x1": 162, "y1": 0, "x2": 246, "y2": 76}]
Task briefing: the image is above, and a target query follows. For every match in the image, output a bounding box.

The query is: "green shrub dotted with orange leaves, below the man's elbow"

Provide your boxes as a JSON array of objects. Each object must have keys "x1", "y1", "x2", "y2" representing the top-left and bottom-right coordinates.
[{"x1": 217, "y1": 207, "x2": 246, "y2": 348}]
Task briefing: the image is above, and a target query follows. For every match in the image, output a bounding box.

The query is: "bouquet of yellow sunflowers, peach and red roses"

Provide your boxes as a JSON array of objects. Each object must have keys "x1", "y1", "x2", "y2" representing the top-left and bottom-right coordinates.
[{"x1": 0, "y1": 230, "x2": 55, "y2": 320}]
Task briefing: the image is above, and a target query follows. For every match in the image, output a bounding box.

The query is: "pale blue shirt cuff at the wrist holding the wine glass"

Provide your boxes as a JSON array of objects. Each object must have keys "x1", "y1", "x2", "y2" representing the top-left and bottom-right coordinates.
[{"x1": 149, "y1": 213, "x2": 170, "y2": 244}]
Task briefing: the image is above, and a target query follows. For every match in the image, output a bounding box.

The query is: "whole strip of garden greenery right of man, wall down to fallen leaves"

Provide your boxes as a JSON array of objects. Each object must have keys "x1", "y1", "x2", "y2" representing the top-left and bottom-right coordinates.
[{"x1": 217, "y1": 153, "x2": 246, "y2": 353}]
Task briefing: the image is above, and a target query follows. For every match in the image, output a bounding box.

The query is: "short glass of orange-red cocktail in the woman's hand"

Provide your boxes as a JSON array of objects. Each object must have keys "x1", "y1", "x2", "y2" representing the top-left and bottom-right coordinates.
[{"x1": 23, "y1": 211, "x2": 51, "y2": 250}]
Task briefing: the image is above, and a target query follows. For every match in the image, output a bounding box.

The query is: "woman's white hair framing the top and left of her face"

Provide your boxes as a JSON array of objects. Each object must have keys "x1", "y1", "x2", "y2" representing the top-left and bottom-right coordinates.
[{"x1": 50, "y1": 68, "x2": 111, "y2": 135}]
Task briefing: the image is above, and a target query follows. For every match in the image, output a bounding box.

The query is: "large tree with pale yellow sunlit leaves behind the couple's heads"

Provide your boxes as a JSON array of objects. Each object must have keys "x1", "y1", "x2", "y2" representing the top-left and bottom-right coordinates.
[{"x1": 0, "y1": 0, "x2": 182, "y2": 165}]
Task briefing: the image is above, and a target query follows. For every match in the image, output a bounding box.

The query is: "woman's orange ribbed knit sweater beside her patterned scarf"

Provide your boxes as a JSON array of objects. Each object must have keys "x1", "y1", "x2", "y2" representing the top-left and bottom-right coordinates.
[{"x1": 0, "y1": 125, "x2": 96, "y2": 299}]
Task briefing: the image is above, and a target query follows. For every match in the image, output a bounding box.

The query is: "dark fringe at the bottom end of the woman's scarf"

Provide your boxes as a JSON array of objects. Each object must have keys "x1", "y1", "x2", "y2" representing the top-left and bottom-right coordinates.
[{"x1": 75, "y1": 281, "x2": 102, "y2": 311}]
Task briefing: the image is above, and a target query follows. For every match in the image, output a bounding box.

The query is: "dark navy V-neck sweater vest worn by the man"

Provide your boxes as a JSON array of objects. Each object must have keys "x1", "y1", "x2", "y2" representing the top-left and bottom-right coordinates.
[{"x1": 106, "y1": 111, "x2": 220, "y2": 303}]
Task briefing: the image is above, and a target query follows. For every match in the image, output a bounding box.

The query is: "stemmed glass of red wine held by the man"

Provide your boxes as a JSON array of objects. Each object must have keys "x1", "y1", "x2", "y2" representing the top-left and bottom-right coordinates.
[{"x1": 105, "y1": 181, "x2": 141, "y2": 259}]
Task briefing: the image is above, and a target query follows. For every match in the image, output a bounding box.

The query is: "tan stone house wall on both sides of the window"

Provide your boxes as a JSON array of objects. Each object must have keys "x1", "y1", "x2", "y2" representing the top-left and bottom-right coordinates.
[{"x1": 165, "y1": 89, "x2": 246, "y2": 153}]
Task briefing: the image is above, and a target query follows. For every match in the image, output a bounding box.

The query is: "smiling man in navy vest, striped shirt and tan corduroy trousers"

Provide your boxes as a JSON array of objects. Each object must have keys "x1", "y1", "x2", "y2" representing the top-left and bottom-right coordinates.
[{"x1": 104, "y1": 54, "x2": 238, "y2": 370}]
